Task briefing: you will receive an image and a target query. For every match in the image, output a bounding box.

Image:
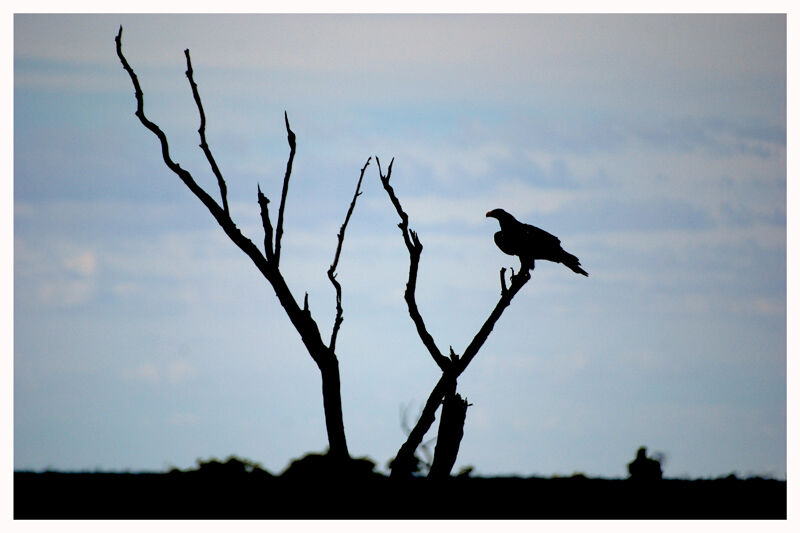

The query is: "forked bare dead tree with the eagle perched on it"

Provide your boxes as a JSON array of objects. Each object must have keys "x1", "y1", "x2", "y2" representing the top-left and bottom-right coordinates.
[{"x1": 375, "y1": 157, "x2": 530, "y2": 478}]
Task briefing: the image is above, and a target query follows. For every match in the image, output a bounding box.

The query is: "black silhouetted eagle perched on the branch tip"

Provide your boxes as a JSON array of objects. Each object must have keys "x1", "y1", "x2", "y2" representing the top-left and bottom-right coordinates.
[{"x1": 486, "y1": 209, "x2": 589, "y2": 276}]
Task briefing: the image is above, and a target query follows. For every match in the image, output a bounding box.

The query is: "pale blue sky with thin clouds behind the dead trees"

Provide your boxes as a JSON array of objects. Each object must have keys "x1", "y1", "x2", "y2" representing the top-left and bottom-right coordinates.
[{"x1": 13, "y1": 15, "x2": 787, "y2": 477}]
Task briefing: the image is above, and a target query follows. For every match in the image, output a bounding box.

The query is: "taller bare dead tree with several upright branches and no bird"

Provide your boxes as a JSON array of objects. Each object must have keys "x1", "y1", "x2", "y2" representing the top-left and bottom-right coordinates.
[{"x1": 115, "y1": 26, "x2": 372, "y2": 460}]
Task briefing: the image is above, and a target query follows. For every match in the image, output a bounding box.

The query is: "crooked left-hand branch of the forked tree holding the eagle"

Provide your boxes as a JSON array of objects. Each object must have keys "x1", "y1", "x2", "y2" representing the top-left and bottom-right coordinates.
[{"x1": 375, "y1": 156, "x2": 450, "y2": 372}]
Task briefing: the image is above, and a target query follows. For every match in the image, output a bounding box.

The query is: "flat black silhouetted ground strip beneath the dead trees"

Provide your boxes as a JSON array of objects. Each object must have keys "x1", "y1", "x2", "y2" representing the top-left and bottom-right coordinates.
[{"x1": 14, "y1": 454, "x2": 786, "y2": 519}]
